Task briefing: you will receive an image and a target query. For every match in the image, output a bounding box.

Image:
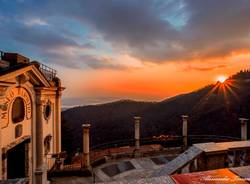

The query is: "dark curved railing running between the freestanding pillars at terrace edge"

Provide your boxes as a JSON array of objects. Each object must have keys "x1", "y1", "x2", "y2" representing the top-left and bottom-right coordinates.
[{"x1": 87, "y1": 135, "x2": 241, "y2": 164}]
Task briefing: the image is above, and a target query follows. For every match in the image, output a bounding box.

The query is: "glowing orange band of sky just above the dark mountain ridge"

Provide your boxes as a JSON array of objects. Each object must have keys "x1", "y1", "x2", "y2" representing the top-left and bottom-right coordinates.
[{"x1": 58, "y1": 53, "x2": 250, "y2": 103}]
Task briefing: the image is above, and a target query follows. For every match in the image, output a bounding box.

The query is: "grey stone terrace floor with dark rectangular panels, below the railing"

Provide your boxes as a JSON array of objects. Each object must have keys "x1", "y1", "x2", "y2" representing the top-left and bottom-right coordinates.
[{"x1": 51, "y1": 154, "x2": 177, "y2": 184}]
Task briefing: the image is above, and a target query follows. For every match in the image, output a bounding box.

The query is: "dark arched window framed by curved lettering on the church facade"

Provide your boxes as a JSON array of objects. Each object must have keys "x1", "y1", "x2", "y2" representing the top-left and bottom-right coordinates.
[{"x1": 12, "y1": 97, "x2": 25, "y2": 123}]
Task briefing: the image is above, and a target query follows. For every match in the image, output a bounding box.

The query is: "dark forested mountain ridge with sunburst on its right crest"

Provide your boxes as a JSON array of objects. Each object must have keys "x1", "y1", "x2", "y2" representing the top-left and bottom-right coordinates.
[{"x1": 62, "y1": 70, "x2": 250, "y2": 152}]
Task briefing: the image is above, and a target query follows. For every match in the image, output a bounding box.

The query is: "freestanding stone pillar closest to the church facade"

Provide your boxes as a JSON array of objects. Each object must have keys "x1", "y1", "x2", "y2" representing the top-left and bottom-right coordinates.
[{"x1": 82, "y1": 124, "x2": 90, "y2": 168}]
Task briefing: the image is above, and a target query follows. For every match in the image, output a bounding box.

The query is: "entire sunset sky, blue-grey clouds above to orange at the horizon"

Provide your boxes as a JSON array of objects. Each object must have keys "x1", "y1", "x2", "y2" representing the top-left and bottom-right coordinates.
[{"x1": 0, "y1": 0, "x2": 250, "y2": 107}]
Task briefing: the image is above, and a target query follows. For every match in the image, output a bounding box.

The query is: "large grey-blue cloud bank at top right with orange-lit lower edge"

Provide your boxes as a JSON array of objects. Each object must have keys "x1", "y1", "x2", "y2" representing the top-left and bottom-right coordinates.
[{"x1": 36, "y1": 0, "x2": 250, "y2": 62}]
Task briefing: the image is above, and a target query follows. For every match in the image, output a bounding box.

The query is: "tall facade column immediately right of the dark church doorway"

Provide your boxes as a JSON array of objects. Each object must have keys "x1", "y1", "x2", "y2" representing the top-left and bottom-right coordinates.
[{"x1": 35, "y1": 95, "x2": 47, "y2": 184}]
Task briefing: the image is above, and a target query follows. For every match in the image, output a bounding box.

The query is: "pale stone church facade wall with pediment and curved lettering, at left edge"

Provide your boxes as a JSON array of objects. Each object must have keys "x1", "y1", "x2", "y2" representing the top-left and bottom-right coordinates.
[{"x1": 0, "y1": 71, "x2": 61, "y2": 182}]
